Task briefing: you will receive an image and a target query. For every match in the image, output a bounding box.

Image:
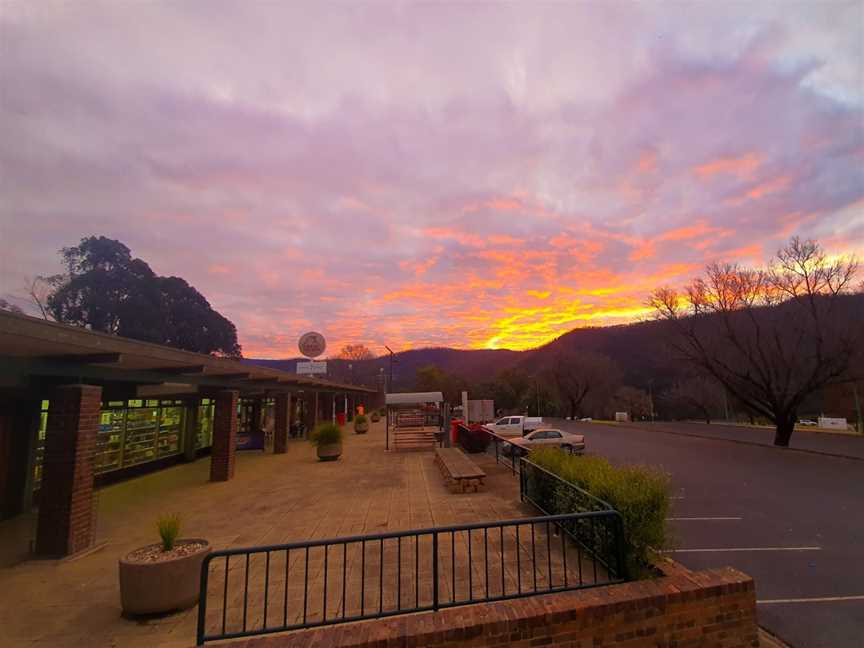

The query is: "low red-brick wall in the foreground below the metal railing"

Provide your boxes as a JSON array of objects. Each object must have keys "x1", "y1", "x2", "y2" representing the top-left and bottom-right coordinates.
[{"x1": 240, "y1": 567, "x2": 759, "y2": 648}]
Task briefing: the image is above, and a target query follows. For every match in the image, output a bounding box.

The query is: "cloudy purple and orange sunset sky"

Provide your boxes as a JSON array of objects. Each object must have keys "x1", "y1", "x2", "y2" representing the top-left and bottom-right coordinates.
[{"x1": 0, "y1": 0, "x2": 864, "y2": 358}]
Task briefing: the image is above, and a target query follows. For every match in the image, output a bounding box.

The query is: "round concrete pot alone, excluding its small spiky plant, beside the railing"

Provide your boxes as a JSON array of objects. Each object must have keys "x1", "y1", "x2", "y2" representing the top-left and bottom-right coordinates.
[{"x1": 119, "y1": 538, "x2": 211, "y2": 616}]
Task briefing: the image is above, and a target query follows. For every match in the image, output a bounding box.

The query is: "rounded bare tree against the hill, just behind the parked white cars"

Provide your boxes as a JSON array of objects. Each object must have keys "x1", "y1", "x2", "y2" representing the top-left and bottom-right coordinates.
[{"x1": 545, "y1": 350, "x2": 620, "y2": 418}]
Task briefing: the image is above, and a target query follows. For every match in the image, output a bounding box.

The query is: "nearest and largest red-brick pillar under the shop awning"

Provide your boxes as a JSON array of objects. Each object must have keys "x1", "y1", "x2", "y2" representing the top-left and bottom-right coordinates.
[{"x1": 36, "y1": 385, "x2": 102, "y2": 557}]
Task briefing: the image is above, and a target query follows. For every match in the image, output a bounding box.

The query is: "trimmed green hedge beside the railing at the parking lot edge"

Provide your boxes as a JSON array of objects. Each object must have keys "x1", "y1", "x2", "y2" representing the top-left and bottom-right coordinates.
[{"x1": 530, "y1": 448, "x2": 671, "y2": 576}]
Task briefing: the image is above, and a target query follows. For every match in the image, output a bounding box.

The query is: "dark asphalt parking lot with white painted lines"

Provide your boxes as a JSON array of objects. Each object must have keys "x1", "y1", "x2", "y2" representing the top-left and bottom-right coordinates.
[{"x1": 555, "y1": 421, "x2": 864, "y2": 648}]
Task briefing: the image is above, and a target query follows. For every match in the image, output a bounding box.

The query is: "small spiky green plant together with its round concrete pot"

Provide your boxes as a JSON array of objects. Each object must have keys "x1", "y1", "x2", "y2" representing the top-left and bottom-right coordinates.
[{"x1": 120, "y1": 514, "x2": 210, "y2": 616}]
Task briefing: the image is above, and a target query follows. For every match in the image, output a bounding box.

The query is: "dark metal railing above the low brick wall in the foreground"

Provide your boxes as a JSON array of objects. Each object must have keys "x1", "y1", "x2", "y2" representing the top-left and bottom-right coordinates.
[{"x1": 197, "y1": 512, "x2": 625, "y2": 645}]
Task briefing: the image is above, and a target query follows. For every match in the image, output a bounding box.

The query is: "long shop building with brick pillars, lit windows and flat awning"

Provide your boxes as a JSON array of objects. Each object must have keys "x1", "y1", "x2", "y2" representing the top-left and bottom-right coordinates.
[{"x1": 0, "y1": 311, "x2": 380, "y2": 556}]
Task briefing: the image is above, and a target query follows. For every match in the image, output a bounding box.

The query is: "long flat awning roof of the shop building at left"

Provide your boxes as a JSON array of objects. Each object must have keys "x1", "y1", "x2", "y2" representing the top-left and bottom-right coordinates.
[{"x1": 0, "y1": 311, "x2": 375, "y2": 393}]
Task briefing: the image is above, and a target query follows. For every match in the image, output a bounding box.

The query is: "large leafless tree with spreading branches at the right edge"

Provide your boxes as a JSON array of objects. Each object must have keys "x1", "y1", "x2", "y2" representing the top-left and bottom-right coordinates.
[{"x1": 651, "y1": 237, "x2": 861, "y2": 446}]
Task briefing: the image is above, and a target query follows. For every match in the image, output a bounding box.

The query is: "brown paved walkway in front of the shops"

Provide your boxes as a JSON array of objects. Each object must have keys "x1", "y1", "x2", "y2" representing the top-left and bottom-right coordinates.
[{"x1": 0, "y1": 425, "x2": 578, "y2": 648}]
